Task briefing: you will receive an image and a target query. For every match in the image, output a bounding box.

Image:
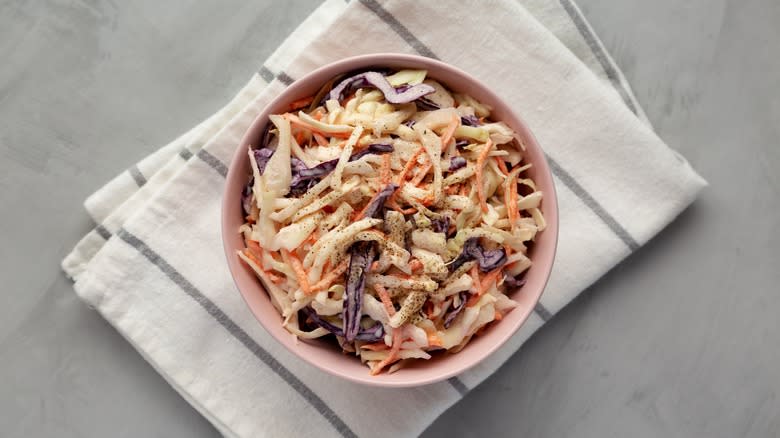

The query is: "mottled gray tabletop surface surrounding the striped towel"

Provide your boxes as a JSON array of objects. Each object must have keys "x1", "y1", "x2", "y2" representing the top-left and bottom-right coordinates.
[{"x1": 0, "y1": 0, "x2": 780, "y2": 437}]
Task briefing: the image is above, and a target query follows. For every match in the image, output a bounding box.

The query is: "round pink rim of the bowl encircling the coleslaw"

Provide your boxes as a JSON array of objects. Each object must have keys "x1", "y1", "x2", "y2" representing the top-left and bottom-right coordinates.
[{"x1": 220, "y1": 53, "x2": 559, "y2": 388}]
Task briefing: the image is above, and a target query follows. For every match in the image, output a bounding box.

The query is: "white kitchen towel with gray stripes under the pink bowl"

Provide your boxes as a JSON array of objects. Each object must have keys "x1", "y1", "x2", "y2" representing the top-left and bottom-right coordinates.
[{"x1": 63, "y1": 0, "x2": 705, "y2": 437}]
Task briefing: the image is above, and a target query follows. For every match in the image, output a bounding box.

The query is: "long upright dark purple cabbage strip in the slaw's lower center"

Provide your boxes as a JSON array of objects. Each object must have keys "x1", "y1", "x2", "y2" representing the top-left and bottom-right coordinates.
[{"x1": 341, "y1": 242, "x2": 374, "y2": 342}]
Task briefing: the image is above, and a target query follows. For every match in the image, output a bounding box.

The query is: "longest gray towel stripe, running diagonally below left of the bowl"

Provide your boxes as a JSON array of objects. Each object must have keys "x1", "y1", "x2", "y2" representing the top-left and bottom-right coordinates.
[{"x1": 117, "y1": 228, "x2": 357, "y2": 437}]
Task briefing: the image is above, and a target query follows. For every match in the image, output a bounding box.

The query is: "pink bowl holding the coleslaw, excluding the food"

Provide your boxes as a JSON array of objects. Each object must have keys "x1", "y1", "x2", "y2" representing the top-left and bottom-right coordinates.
[{"x1": 222, "y1": 53, "x2": 558, "y2": 387}]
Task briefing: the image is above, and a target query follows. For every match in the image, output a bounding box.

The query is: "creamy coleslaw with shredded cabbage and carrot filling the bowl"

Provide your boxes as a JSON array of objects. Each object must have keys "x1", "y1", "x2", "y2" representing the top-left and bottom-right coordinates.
[{"x1": 238, "y1": 70, "x2": 545, "y2": 374}]
